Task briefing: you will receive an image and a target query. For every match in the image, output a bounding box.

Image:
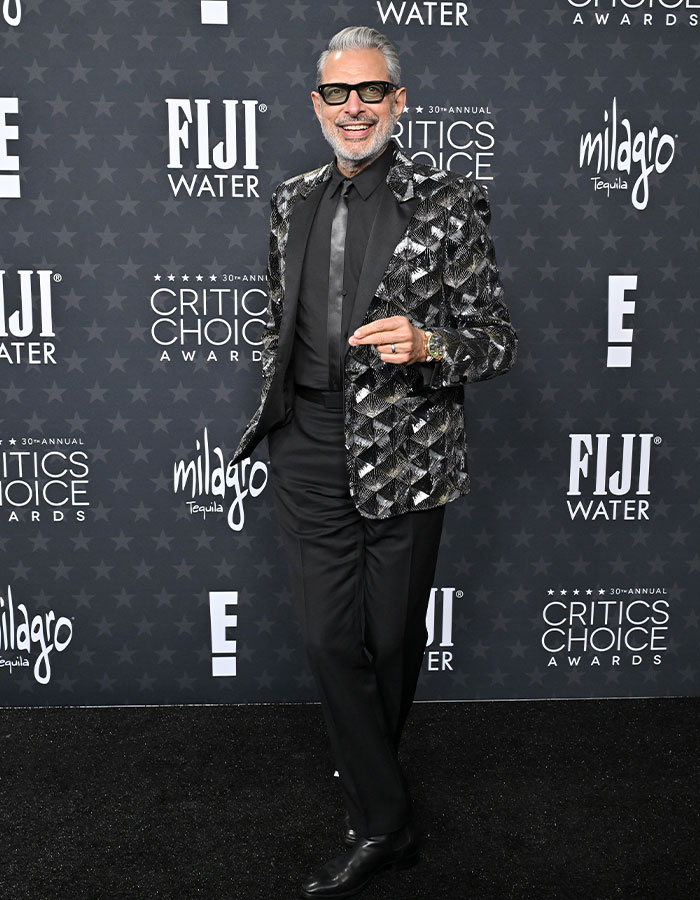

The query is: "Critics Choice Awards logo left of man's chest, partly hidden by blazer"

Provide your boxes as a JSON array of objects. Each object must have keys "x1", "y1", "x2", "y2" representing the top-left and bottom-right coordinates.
[{"x1": 149, "y1": 273, "x2": 268, "y2": 364}]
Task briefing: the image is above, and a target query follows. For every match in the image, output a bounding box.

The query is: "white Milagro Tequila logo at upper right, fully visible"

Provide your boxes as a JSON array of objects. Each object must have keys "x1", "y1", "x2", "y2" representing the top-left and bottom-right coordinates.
[{"x1": 579, "y1": 97, "x2": 676, "y2": 209}]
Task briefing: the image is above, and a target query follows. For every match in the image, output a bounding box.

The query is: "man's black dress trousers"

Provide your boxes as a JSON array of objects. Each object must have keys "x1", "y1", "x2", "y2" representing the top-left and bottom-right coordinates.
[{"x1": 268, "y1": 394, "x2": 445, "y2": 837}]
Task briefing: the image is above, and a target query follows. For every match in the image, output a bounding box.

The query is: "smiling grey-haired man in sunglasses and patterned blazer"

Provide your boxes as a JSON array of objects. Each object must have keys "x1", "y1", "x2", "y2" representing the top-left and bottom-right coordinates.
[{"x1": 234, "y1": 27, "x2": 516, "y2": 898}]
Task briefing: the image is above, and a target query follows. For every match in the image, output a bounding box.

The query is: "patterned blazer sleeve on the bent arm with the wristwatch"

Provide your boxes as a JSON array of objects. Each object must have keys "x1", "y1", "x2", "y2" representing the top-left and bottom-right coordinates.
[{"x1": 419, "y1": 179, "x2": 517, "y2": 388}]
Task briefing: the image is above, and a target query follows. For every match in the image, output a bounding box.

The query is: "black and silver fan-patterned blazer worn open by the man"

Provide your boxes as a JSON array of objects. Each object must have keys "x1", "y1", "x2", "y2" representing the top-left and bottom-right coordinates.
[{"x1": 233, "y1": 142, "x2": 517, "y2": 519}]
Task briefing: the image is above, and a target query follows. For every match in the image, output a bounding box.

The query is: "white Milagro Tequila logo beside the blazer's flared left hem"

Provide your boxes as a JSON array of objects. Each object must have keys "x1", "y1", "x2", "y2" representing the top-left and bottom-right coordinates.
[{"x1": 173, "y1": 428, "x2": 267, "y2": 531}]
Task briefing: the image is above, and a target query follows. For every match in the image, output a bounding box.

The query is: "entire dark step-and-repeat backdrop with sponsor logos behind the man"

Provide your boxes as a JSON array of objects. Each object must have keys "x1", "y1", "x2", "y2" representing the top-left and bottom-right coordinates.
[{"x1": 0, "y1": 0, "x2": 700, "y2": 706}]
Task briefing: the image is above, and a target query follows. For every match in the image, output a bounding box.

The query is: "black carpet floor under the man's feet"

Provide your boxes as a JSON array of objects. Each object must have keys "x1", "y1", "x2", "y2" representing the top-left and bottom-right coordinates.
[{"x1": 0, "y1": 698, "x2": 700, "y2": 900}]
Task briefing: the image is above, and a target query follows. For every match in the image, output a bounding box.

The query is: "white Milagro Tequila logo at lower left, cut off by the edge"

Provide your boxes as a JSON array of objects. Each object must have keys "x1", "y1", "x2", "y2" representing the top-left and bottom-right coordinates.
[{"x1": 0, "y1": 585, "x2": 73, "y2": 684}]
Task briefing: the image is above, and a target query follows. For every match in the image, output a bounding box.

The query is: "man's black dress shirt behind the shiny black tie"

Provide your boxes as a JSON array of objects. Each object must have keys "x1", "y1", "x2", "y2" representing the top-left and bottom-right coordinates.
[{"x1": 294, "y1": 144, "x2": 393, "y2": 391}]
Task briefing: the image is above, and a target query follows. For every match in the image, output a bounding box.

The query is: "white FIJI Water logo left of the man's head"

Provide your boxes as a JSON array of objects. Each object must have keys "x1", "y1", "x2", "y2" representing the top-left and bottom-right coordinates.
[{"x1": 165, "y1": 98, "x2": 267, "y2": 199}]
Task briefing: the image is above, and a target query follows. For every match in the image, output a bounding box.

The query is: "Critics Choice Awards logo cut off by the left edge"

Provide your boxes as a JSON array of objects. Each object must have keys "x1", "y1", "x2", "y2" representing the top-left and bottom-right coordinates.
[{"x1": 0, "y1": 437, "x2": 90, "y2": 522}]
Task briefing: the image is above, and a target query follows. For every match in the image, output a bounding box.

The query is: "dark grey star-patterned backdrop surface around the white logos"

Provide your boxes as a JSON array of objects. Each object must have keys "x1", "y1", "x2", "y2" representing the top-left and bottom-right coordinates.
[{"x1": 0, "y1": 0, "x2": 700, "y2": 705}]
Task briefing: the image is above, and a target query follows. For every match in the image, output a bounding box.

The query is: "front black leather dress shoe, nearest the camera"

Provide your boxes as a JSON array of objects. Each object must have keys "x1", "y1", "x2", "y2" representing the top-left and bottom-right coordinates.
[{"x1": 301, "y1": 826, "x2": 418, "y2": 900}]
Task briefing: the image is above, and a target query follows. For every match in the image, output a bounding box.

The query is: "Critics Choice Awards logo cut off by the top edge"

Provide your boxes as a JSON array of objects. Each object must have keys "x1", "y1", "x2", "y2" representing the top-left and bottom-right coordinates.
[{"x1": 568, "y1": 0, "x2": 700, "y2": 26}]
